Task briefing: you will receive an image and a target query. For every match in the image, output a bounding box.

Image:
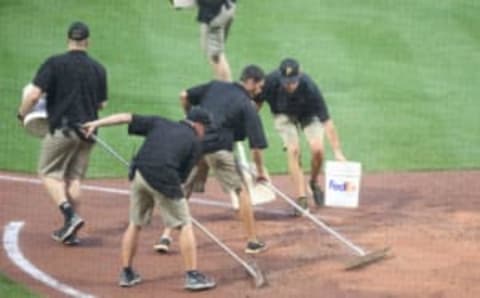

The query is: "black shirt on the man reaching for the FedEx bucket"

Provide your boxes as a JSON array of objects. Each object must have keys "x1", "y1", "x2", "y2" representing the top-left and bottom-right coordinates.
[{"x1": 255, "y1": 70, "x2": 330, "y2": 122}]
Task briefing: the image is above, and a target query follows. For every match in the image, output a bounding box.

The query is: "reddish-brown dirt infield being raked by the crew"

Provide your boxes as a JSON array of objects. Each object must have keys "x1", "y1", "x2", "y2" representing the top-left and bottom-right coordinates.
[{"x1": 0, "y1": 171, "x2": 480, "y2": 298}]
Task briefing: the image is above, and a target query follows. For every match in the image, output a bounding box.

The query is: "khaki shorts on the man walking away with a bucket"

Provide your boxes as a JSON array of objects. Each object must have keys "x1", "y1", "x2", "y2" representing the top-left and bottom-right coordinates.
[{"x1": 38, "y1": 129, "x2": 93, "y2": 180}]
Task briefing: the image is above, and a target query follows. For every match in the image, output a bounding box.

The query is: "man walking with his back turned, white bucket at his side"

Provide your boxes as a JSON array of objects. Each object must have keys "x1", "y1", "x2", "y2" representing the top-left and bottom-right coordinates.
[{"x1": 18, "y1": 22, "x2": 107, "y2": 244}]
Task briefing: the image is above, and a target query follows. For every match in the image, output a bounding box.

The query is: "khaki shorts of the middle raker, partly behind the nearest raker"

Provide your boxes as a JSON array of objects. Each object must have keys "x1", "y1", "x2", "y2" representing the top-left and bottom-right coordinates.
[{"x1": 185, "y1": 150, "x2": 243, "y2": 193}]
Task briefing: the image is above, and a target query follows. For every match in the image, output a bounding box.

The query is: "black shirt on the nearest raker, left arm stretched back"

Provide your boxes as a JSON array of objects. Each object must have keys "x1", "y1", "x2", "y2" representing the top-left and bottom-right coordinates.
[{"x1": 128, "y1": 115, "x2": 201, "y2": 199}]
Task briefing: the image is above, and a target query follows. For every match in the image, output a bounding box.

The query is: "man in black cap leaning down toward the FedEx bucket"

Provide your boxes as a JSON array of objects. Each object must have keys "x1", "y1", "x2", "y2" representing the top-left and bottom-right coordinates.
[{"x1": 255, "y1": 58, "x2": 345, "y2": 215}]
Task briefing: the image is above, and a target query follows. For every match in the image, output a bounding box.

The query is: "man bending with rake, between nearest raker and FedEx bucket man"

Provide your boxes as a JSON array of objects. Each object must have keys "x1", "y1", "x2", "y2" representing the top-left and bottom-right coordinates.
[{"x1": 154, "y1": 65, "x2": 267, "y2": 254}]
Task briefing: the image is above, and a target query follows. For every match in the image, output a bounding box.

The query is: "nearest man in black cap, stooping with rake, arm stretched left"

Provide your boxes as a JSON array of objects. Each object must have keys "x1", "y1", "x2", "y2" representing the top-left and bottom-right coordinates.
[{"x1": 83, "y1": 108, "x2": 215, "y2": 291}]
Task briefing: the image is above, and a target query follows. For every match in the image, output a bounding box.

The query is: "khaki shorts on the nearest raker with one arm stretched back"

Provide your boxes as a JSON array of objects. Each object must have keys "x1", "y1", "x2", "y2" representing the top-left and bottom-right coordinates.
[{"x1": 130, "y1": 170, "x2": 190, "y2": 228}]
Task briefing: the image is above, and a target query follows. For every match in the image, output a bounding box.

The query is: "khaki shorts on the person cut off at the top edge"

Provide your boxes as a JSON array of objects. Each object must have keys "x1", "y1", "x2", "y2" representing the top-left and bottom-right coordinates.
[{"x1": 200, "y1": 2, "x2": 236, "y2": 57}]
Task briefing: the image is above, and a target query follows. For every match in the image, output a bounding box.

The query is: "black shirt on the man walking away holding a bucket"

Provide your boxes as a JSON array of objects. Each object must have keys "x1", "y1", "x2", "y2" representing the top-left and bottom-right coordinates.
[{"x1": 33, "y1": 51, "x2": 107, "y2": 131}]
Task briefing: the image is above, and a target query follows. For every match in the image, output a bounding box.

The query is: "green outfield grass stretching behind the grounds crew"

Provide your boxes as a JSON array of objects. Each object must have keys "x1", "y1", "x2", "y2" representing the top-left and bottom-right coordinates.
[{"x1": 0, "y1": 0, "x2": 480, "y2": 177}]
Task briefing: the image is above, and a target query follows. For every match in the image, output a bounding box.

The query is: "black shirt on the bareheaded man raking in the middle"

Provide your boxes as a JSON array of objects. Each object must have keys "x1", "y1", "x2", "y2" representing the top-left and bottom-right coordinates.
[{"x1": 187, "y1": 81, "x2": 268, "y2": 153}]
